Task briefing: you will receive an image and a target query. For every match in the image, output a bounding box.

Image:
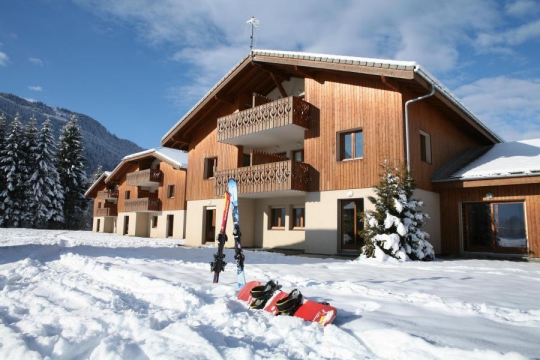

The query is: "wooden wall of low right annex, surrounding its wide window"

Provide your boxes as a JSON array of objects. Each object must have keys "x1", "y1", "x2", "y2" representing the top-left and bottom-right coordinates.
[{"x1": 440, "y1": 184, "x2": 540, "y2": 258}]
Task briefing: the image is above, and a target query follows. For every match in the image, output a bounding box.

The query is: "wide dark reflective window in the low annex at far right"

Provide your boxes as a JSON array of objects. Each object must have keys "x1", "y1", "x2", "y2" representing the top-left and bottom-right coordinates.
[{"x1": 462, "y1": 202, "x2": 527, "y2": 253}]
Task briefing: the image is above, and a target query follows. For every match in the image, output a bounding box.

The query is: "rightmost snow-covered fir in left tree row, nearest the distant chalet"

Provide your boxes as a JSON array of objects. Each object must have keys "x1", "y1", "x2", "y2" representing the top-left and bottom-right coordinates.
[{"x1": 56, "y1": 115, "x2": 88, "y2": 229}]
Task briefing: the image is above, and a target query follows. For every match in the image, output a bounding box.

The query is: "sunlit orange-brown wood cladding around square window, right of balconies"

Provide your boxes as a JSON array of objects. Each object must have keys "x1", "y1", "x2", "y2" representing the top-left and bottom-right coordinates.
[{"x1": 304, "y1": 74, "x2": 405, "y2": 191}]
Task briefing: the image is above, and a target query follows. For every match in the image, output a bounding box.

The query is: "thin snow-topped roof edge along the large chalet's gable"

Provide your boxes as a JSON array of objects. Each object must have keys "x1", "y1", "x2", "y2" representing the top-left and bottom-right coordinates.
[{"x1": 161, "y1": 50, "x2": 504, "y2": 142}]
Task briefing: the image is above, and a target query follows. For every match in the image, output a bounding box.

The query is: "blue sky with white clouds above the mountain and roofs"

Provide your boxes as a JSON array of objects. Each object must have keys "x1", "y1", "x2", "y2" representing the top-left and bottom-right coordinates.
[{"x1": 0, "y1": 0, "x2": 540, "y2": 148}]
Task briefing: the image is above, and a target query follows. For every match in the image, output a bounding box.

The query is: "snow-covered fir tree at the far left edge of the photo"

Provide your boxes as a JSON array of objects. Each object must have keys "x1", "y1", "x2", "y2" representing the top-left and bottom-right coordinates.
[{"x1": 0, "y1": 113, "x2": 26, "y2": 227}]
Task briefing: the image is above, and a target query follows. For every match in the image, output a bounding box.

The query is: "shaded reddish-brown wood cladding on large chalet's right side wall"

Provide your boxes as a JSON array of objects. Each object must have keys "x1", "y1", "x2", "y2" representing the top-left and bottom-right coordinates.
[{"x1": 403, "y1": 91, "x2": 489, "y2": 191}]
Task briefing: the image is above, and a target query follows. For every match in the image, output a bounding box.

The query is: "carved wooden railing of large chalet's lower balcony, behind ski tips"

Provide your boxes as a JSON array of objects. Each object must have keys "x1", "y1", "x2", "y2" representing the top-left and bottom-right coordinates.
[{"x1": 215, "y1": 160, "x2": 309, "y2": 196}]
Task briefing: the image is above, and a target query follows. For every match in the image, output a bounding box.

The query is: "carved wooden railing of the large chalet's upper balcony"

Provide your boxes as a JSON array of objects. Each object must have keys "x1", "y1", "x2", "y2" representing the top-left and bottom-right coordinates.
[{"x1": 217, "y1": 96, "x2": 311, "y2": 141}]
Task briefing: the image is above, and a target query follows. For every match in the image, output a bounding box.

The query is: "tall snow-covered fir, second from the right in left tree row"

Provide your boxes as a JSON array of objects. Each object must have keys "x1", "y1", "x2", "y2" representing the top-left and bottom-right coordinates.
[{"x1": 29, "y1": 119, "x2": 64, "y2": 228}]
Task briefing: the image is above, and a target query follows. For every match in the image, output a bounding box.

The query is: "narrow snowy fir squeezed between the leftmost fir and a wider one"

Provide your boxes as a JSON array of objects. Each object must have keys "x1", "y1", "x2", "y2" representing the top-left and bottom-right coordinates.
[{"x1": 20, "y1": 114, "x2": 38, "y2": 227}]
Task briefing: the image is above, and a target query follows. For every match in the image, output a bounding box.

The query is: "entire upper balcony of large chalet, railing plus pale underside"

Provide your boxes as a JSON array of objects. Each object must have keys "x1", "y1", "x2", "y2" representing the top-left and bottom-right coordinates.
[{"x1": 217, "y1": 96, "x2": 311, "y2": 149}]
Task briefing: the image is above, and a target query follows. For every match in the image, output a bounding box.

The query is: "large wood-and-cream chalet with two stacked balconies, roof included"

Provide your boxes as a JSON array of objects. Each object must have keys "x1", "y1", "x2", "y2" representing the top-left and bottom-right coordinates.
[{"x1": 158, "y1": 51, "x2": 524, "y2": 254}]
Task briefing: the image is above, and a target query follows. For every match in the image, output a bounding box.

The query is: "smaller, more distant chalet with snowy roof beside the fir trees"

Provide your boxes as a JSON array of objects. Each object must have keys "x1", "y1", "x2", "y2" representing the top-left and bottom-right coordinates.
[{"x1": 85, "y1": 147, "x2": 187, "y2": 239}]
